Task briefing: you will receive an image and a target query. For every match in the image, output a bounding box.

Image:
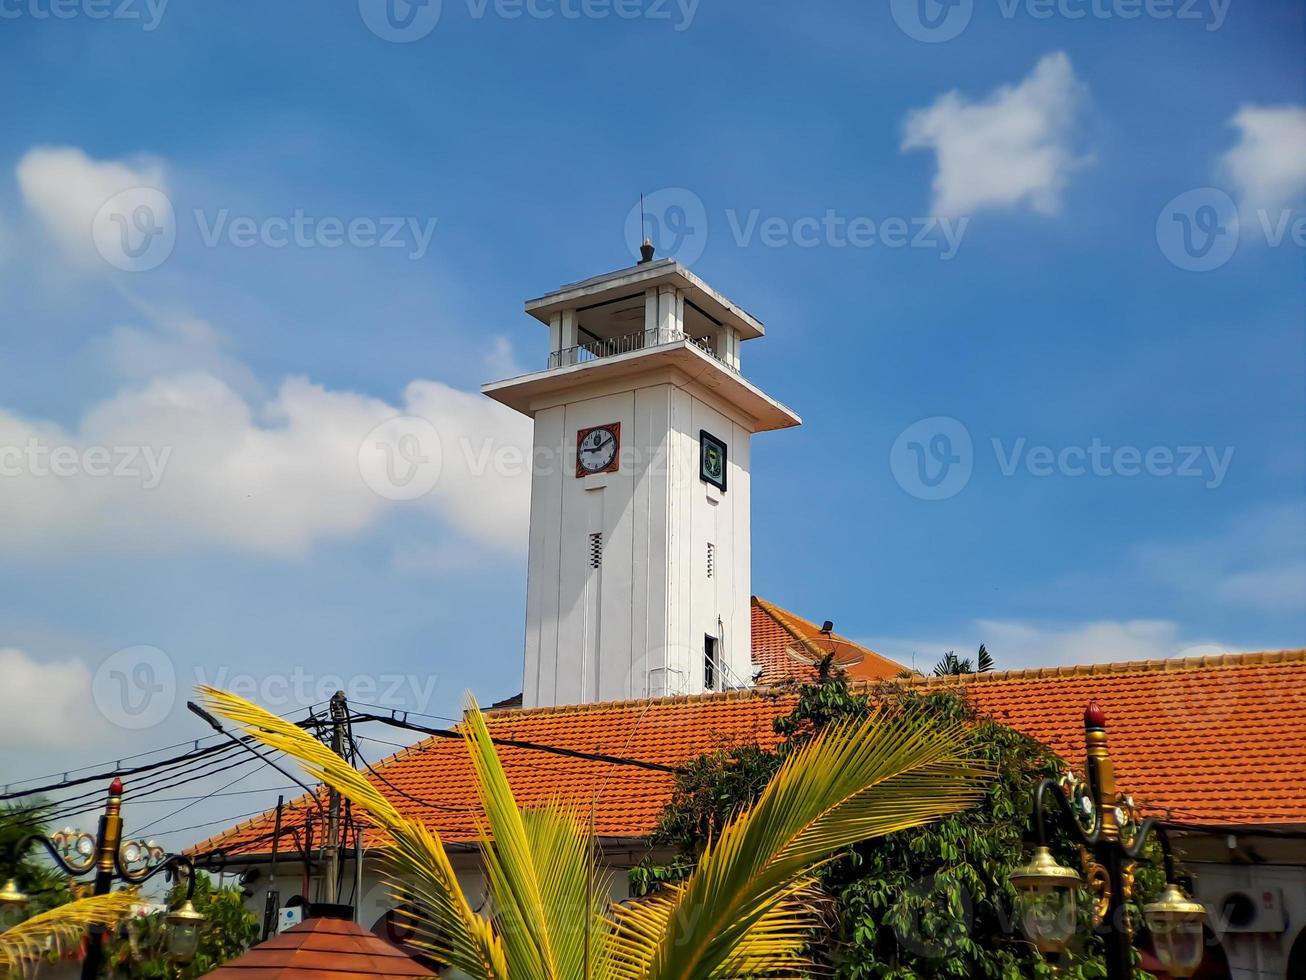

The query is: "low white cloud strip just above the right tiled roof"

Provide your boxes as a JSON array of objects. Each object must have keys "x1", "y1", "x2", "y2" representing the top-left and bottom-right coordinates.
[{"x1": 867, "y1": 619, "x2": 1239, "y2": 673}]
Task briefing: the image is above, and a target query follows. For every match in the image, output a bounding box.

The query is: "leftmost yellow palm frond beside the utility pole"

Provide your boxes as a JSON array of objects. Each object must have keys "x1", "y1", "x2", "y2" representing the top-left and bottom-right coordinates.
[{"x1": 199, "y1": 686, "x2": 508, "y2": 980}]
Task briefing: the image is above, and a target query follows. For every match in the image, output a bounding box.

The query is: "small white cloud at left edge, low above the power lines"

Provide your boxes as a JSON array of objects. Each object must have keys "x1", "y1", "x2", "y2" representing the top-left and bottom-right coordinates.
[{"x1": 0, "y1": 647, "x2": 94, "y2": 755}]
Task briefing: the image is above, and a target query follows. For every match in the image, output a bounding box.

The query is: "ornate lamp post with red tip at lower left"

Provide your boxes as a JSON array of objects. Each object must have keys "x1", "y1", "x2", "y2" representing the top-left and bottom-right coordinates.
[{"x1": 0, "y1": 779, "x2": 204, "y2": 980}]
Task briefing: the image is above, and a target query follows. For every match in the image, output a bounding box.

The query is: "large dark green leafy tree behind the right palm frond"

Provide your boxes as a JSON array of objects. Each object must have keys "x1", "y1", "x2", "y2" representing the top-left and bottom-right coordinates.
[{"x1": 631, "y1": 676, "x2": 1162, "y2": 980}]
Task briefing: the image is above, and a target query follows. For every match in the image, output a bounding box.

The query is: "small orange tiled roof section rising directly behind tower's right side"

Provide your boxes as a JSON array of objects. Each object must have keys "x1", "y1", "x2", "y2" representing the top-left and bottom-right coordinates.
[{"x1": 752, "y1": 596, "x2": 906, "y2": 687}]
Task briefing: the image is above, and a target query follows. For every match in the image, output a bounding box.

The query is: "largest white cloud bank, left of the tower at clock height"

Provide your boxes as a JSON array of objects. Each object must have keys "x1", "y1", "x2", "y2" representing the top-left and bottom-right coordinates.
[{"x1": 0, "y1": 363, "x2": 532, "y2": 557}]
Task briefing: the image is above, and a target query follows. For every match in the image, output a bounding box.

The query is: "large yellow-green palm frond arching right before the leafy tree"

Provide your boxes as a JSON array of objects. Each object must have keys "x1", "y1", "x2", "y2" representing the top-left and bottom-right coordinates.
[{"x1": 626, "y1": 713, "x2": 989, "y2": 979}]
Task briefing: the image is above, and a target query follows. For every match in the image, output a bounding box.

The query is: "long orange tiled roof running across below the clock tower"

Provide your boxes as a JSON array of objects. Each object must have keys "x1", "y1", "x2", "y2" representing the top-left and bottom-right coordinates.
[{"x1": 193, "y1": 649, "x2": 1306, "y2": 853}]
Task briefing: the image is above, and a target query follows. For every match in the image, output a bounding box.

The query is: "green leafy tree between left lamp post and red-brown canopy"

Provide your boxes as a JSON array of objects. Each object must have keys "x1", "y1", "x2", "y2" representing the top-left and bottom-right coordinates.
[{"x1": 106, "y1": 873, "x2": 260, "y2": 980}]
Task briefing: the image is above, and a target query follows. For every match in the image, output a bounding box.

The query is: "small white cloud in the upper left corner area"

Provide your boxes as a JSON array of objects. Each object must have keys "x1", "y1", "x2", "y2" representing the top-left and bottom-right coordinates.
[{"x1": 16, "y1": 146, "x2": 167, "y2": 267}]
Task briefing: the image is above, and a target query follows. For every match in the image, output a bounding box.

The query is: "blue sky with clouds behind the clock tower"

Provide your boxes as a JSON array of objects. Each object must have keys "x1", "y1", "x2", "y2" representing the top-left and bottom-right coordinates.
[{"x1": 0, "y1": 0, "x2": 1306, "y2": 851}]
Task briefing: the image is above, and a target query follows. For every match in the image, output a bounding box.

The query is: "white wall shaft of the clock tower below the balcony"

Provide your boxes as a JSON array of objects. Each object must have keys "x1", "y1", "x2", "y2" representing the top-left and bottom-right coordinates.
[{"x1": 524, "y1": 383, "x2": 751, "y2": 707}]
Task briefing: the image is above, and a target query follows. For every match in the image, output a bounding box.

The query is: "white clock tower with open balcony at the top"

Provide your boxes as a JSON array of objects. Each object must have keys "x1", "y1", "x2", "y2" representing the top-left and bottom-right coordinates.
[{"x1": 482, "y1": 253, "x2": 801, "y2": 708}]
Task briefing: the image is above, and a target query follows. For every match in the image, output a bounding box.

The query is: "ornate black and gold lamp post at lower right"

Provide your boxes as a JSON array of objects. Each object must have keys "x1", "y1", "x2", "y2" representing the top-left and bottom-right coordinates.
[{"x1": 1011, "y1": 702, "x2": 1205, "y2": 980}]
